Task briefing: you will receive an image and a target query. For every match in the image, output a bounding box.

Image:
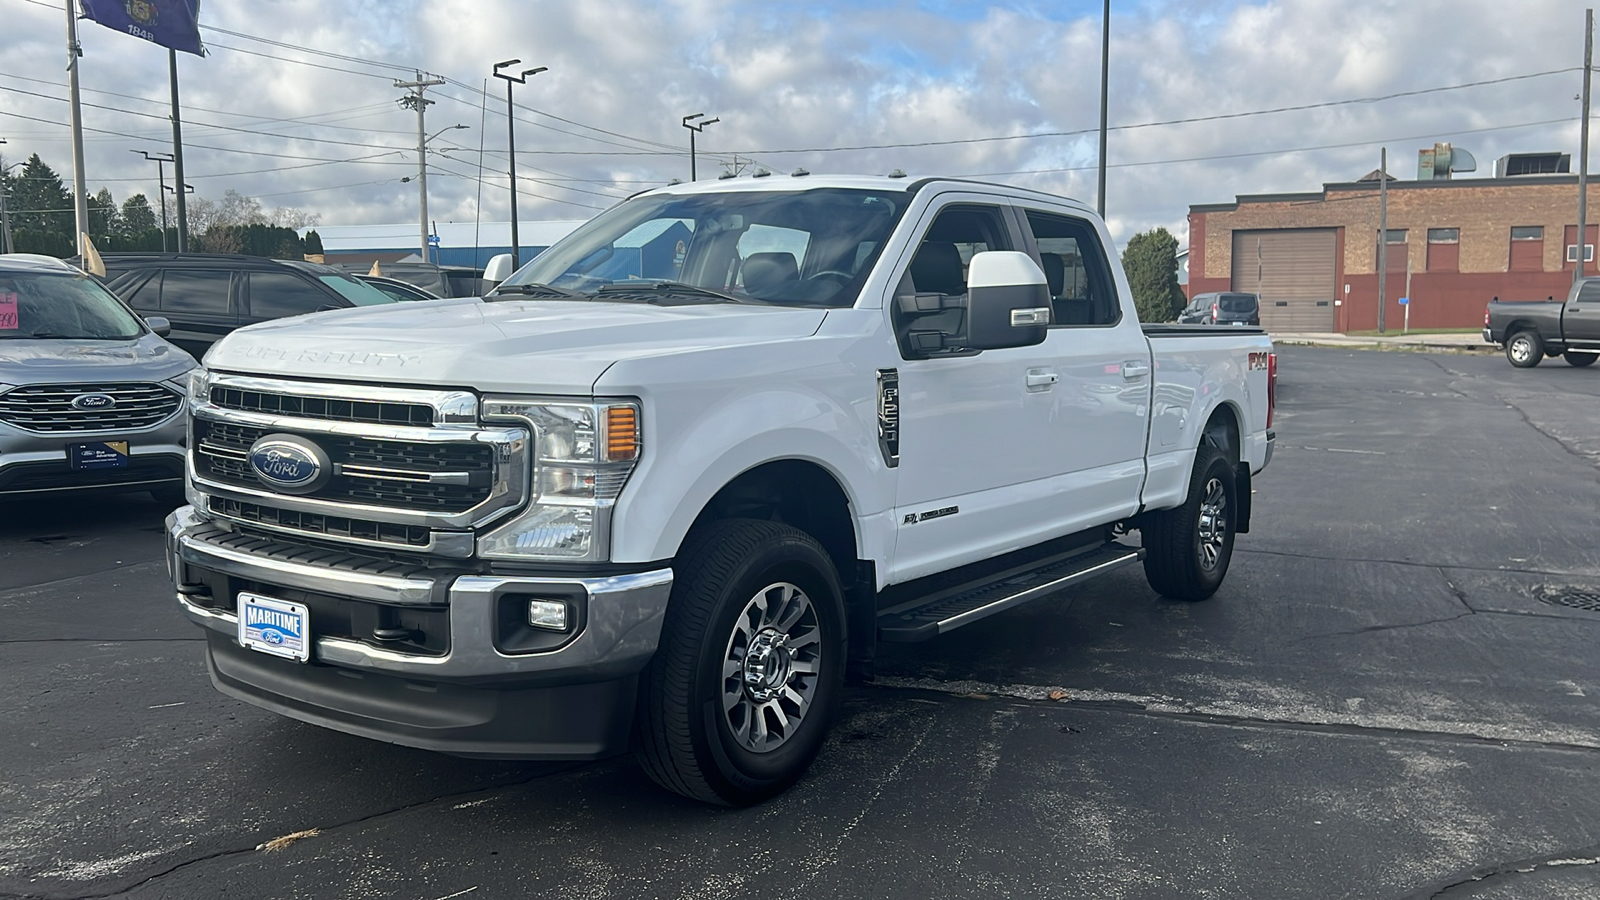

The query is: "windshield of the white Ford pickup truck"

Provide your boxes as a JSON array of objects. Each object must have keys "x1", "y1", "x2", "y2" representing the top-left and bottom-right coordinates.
[{"x1": 496, "y1": 187, "x2": 910, "y2": 306}]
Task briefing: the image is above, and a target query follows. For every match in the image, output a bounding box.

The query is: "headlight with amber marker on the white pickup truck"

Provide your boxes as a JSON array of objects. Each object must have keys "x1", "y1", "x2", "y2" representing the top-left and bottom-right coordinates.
[{"x1": 478, "y1": 397, "x2": 642, "y2": 562}]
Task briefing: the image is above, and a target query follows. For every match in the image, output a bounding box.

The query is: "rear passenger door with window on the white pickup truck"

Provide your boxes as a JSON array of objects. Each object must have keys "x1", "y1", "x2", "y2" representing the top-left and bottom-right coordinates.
[{"x1": 1021, "y1": 205, "x2": 1155, "y2": 533}]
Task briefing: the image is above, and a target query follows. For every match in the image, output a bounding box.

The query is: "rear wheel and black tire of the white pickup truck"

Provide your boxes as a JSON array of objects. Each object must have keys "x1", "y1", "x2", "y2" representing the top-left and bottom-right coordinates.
[{"x1": 1139, "y1": 444, "x2": 1238, "y2": 602}]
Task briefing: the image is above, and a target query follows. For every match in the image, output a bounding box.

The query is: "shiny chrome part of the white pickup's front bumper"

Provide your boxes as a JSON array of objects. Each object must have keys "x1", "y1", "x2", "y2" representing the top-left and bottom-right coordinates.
[{"x1": 166, "y1": 506, "x2": 672, "y2": 682}]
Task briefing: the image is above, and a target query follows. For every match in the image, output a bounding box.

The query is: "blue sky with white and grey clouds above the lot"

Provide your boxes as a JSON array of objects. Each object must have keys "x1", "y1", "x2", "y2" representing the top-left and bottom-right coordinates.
[{"x1": 0, "y1": 0, "x2": 1584, "y2": 242}]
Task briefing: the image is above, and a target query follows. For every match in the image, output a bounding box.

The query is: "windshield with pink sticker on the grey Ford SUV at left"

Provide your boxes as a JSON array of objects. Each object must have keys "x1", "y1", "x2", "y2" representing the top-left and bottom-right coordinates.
[{"x1": 0, "y1": 272, "x2": 144, "y2": 341}]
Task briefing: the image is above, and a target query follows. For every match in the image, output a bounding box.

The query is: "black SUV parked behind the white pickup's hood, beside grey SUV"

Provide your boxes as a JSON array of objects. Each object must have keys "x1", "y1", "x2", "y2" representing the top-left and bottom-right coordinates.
[{"x1": 104, "y1": 253, "x2": 394, "y2": 359}]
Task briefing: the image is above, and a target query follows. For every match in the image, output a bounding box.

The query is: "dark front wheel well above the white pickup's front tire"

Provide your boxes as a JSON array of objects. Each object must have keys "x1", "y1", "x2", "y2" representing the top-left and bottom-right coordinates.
[{"x1": 690, "y1": 460, "x2": 856, "y2": 573}]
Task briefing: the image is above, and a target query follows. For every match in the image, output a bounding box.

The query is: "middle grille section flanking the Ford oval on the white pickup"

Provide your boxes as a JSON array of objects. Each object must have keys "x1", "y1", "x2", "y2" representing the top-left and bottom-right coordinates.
[{"x1": 194, "y1": 418, "x2": 494, "y2": 512}]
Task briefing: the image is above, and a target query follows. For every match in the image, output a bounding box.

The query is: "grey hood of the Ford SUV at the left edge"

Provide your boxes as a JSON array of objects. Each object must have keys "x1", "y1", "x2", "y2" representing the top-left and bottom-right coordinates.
[{"x1": 0, "y1": 335, "x2": 195, "y2": 384}]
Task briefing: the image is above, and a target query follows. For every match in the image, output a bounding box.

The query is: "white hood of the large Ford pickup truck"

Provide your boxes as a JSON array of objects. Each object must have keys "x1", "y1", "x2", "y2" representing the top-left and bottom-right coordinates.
[{"x1": 205, "y1": 299, "x2": 827, "y2": 394}]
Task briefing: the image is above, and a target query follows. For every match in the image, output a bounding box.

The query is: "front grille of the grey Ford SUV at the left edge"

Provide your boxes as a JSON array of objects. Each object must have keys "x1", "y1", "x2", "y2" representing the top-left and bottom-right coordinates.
[{"x1": 0, "y1": 383, "x2": 182, "y2": 434}]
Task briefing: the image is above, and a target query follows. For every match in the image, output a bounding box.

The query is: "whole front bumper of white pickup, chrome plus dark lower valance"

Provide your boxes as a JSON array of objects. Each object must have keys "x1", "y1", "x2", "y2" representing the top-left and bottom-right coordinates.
[{"x1": 166, "y1": 506, "x2": 672, "y2": 759}]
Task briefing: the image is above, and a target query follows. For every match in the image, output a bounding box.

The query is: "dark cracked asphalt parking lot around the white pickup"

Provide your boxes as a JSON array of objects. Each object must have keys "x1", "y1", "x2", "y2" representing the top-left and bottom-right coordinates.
[{"x1": 0, "y1": 348, "x2": 1600, "y2": 900}]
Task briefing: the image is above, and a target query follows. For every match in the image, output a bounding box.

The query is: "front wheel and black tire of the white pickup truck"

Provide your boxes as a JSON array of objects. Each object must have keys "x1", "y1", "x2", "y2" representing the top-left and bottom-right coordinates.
[{"x1": 634, "y1": 519, "x2": 845, "y2": 806}]
